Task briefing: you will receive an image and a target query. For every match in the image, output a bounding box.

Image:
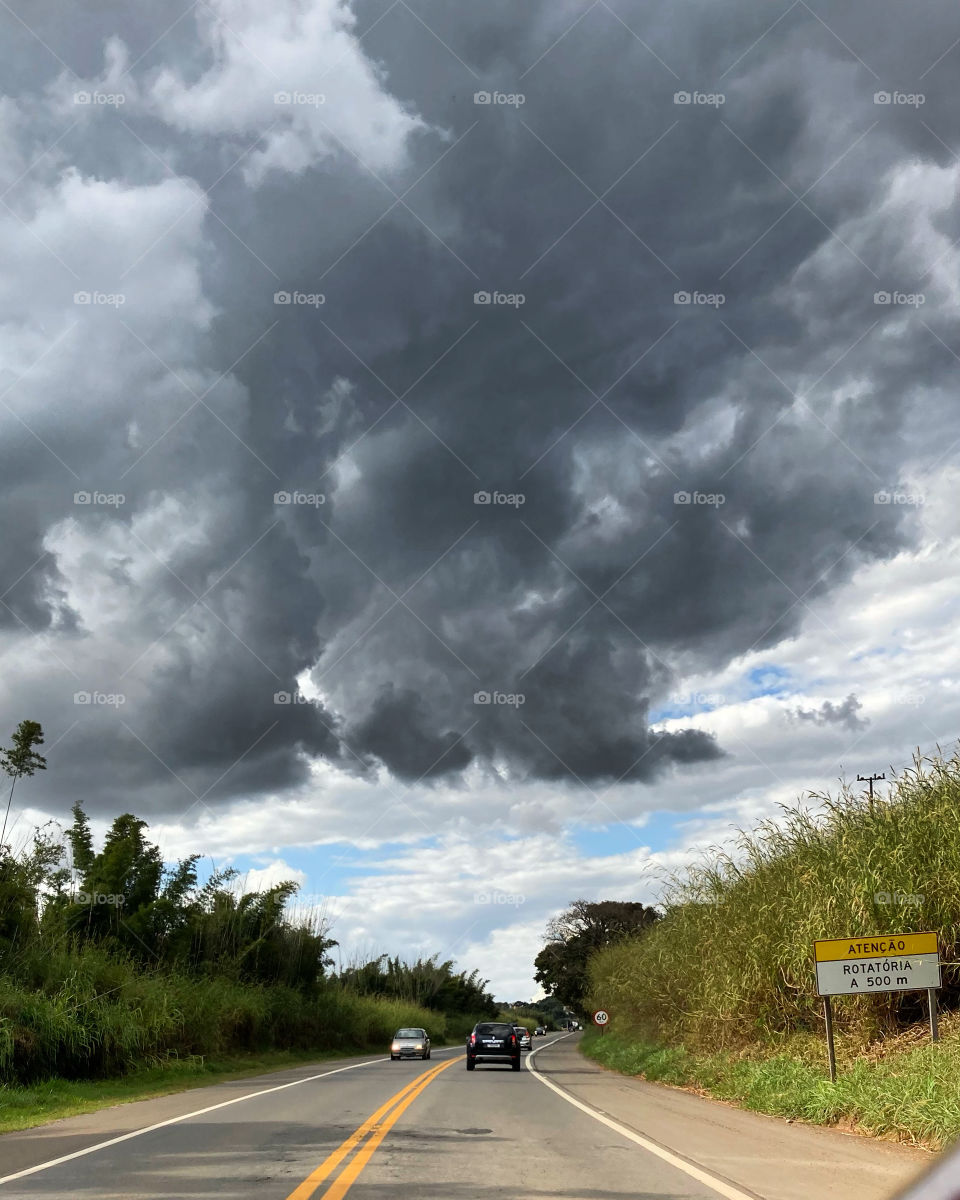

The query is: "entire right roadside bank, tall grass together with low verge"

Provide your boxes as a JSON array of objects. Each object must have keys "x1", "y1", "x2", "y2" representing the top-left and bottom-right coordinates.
[{"x1": 571, "y1": 756, "x2": 960, "y2": 1145}]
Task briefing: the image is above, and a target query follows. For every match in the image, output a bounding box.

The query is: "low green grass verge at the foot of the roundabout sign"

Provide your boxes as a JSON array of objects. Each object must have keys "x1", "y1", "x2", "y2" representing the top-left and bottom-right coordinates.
[{"x1": 581, "y1": 1021, "x2": 960, "y2": 1150}]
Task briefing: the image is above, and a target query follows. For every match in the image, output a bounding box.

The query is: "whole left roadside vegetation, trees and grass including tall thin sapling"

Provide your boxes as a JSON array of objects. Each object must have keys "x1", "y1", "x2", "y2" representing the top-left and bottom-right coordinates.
[{"x1": 0, "y1": 721, "x2": 496, "y2": 1085}]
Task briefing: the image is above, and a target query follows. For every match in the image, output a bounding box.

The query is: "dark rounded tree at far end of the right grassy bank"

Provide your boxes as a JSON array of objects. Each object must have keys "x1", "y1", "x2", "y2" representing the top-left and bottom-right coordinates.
[{"x1": 534, "y1": 900, "x2": 660, "y2": 1012}]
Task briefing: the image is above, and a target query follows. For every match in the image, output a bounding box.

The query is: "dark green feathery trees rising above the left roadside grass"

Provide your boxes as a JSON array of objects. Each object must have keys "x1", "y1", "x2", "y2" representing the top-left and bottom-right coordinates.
[{"x1": 0, "y1": 804, "x2": 338, "y2": 998}]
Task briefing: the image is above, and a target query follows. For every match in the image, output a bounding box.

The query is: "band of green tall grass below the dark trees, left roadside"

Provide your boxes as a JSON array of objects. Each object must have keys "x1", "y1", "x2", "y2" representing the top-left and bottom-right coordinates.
[{"x1": 0, "y1": 947, "x2": 448, "y2": 1084}]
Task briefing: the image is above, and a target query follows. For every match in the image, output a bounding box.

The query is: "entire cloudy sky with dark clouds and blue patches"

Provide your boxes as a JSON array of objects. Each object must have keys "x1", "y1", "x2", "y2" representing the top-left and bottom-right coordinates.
[{"x1": 0, "y1": 0, "x2": 960, "y2": 1000}]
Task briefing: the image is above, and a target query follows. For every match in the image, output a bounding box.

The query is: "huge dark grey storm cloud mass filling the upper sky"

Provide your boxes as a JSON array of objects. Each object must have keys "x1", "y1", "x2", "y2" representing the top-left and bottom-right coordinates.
[{"x1": 0, "y1": 0, "x2": 960, "y2": 806}]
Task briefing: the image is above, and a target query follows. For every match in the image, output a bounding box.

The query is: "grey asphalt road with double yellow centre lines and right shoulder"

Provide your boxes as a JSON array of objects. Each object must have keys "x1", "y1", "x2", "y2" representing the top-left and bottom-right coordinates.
[{"x1": 0, "y1": 1037, "x2": 930, "y2": 1200}]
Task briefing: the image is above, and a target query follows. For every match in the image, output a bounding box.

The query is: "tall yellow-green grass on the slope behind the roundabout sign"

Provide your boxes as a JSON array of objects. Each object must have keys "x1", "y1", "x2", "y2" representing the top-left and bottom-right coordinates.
[{"x1": 589, "y1": 756, "x2": 960, "y2": 1050}]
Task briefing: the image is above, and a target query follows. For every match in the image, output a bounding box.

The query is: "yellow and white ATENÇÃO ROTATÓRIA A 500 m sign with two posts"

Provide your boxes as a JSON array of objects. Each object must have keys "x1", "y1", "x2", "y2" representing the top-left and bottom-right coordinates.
[{"x1": 814, "y1": 934, "x2": 940, "y2": 1084}]
